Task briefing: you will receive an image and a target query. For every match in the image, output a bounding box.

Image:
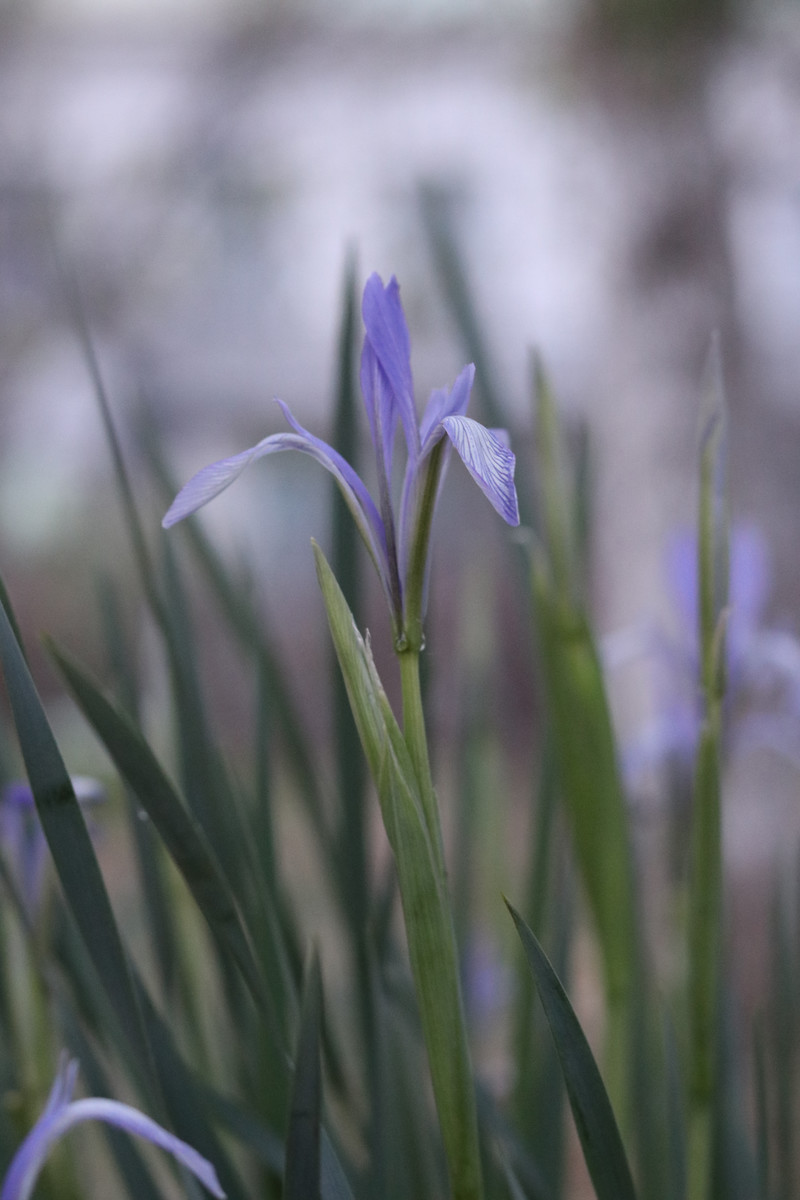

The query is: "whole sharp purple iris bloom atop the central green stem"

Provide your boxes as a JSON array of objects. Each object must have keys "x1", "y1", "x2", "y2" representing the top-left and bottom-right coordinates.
[{"x1": 162, "y1": 275, "x2": 519, "y2": 648}]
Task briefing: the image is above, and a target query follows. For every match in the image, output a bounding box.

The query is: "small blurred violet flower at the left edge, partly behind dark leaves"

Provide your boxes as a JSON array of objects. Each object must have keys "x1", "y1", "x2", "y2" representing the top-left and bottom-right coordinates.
[{"x1": 0, "y1": 775, "x2": 106, "y2": 917}]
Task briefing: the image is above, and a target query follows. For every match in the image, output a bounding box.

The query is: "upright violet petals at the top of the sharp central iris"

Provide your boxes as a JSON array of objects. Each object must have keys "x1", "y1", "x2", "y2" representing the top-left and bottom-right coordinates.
[{"x1": 361, "y1": 274, "x2": 420, "y2": 460}]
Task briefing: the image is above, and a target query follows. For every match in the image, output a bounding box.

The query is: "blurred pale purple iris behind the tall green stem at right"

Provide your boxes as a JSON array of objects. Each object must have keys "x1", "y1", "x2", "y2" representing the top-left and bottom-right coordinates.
[{"x1": 606, "y1": 526, "x2": 800, "y2": 779}]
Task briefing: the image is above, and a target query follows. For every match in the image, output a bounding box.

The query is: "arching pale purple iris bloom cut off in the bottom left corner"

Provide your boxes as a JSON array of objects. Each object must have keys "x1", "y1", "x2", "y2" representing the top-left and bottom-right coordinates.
[{"x1": 0, "y1": 1058, "x2": 225, "y2": 1200}]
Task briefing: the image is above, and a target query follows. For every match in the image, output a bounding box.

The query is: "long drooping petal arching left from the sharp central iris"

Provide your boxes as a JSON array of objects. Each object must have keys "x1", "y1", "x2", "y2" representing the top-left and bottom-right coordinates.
[{"x1": 161, "y1": 401, "x2": 390, "y2": 609}]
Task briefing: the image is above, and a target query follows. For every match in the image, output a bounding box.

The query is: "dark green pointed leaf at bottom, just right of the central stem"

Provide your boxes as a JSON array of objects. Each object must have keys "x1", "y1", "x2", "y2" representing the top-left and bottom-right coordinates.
[{"x1": 506, "y1": 900, "x2": 636, "y2": 1200}]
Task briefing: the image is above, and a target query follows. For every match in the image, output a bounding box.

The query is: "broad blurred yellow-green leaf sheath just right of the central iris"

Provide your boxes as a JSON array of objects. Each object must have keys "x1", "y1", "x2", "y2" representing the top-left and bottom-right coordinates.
[{"x1": 531, "y1": 364, "x2": 638, "y2": 1126}]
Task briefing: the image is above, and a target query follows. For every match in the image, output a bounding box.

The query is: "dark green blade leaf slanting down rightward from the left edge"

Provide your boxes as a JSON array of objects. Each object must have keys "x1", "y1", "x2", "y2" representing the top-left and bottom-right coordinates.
[{"x1": 0, "y1": 580, "x2": 152, "y2": 1078}]
